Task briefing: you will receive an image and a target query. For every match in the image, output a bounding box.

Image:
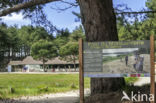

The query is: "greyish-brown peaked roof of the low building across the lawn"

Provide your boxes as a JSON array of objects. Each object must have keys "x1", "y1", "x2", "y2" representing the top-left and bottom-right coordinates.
[{"x1": 9, "y1": 56, "x2": 78, "y2": 65}]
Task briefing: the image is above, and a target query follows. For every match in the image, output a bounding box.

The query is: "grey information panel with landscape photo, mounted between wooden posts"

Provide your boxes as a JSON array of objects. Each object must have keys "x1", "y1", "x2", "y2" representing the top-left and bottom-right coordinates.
[{"x1": 83, "y1": 40, "x2": 150, "y2": 77}]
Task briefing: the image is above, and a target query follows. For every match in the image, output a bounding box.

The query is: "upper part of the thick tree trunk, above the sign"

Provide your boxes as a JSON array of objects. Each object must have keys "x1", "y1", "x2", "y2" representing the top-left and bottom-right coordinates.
[{"x1": 79, "y1": 0, "x2": 118, "y2": 41}]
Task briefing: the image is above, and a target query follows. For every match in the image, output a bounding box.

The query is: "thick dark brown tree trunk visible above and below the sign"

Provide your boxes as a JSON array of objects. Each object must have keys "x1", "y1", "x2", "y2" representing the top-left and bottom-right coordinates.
[{"x1": 78, "y1": 0, "x2": 125, "y2": 95}]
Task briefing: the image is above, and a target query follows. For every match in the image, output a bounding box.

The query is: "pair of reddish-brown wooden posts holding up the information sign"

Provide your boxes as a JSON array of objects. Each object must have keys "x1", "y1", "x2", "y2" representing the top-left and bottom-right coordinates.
[{"x1": 79, "y1": 35, "x2": 156, "y2": 103}]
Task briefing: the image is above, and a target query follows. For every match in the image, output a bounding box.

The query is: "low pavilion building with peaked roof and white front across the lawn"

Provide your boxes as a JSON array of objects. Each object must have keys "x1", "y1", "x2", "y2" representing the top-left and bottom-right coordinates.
[{"x1": 8, "y1": 56, "x2": 78, "y2": 72}]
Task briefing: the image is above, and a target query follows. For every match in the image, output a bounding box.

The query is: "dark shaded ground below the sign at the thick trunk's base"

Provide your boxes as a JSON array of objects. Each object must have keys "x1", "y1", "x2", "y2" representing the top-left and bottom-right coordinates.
[{"x1": 85, "y1": 84, "x2": 153, "y2": 103}]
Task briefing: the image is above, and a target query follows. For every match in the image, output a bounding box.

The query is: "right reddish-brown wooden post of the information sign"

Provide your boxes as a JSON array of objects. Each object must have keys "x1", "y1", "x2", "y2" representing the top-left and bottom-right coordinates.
[{"x1": 150, "y1": 35, "x2": 155, "y2": 103}]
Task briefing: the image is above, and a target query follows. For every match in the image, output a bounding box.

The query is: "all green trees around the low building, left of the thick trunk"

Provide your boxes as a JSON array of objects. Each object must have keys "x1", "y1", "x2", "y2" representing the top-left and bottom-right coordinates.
[{"x1": 0, "y1": 24, "x2": 84, "y2": 69}]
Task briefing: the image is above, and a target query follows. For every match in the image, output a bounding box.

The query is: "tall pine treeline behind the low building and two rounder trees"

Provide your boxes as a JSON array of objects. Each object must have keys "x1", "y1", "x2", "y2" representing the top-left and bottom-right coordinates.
[{"x1": 0, "y1": 24, "x2": 84, "y2": 70}]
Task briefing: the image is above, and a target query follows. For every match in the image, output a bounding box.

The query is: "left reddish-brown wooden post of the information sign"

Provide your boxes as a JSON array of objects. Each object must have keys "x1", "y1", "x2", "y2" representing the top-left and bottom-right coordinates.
[{"x1": 79, "y1": 39, "x2": 84, "y2": 103}]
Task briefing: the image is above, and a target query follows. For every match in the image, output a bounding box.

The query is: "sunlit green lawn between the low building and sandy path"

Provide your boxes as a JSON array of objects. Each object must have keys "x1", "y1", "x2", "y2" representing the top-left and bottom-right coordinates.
[{"x1": 0, "y1": 74, "x2": 90, "y2": 99}]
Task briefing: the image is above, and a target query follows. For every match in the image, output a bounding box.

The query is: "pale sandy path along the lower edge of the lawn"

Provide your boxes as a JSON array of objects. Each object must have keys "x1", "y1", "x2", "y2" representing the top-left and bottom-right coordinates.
[{"x1": 0, "y1": 89, "x2": 90, "y2": 103}]
